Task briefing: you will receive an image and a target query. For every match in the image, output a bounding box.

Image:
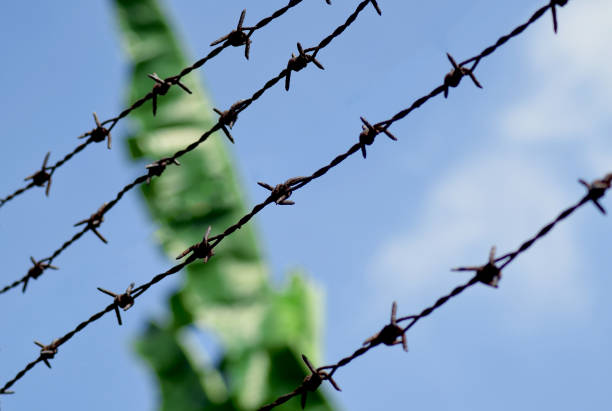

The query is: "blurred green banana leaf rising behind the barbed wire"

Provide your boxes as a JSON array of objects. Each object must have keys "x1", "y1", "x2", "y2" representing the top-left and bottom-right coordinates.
[{"x1": 114, "y1": 0, "x2": 333, "y2": 411}]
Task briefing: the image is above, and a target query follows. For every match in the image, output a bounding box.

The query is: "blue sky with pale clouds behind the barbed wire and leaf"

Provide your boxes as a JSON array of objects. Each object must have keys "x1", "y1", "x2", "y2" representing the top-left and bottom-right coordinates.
[{"x1": 0, "y1": 0, "x2": 612, "y2": 410}]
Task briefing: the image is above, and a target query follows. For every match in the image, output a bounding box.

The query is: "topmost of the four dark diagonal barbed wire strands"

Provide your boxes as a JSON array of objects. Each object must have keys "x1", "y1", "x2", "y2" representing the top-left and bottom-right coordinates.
[{"x1": 0, "y1": 0, "x2": 322, "y2": 208}]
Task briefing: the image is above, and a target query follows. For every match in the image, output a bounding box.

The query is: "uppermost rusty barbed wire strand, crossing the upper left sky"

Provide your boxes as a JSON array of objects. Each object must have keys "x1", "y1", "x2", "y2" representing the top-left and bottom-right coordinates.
[{"x1": 0, "y1": 0, "x2": 331, "y2": 211}]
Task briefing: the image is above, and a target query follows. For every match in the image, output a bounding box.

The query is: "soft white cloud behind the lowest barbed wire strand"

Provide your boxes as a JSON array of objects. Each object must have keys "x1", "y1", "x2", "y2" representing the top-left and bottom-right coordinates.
[{"x1": 369, "y1": 150, "x2": 588, "y2": 328}]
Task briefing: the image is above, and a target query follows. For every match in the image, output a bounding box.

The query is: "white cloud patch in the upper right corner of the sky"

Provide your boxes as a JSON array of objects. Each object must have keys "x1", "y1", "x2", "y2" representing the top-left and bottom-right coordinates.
[{"x1": 499, "y1": 0, "x2": 612, "y2": 173}]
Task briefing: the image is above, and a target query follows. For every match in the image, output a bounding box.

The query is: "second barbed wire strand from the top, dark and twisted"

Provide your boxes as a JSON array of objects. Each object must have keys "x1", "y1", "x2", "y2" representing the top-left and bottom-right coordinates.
[{"x1": 0, "y1": 0, "x2": 380, "y2": 294}]
